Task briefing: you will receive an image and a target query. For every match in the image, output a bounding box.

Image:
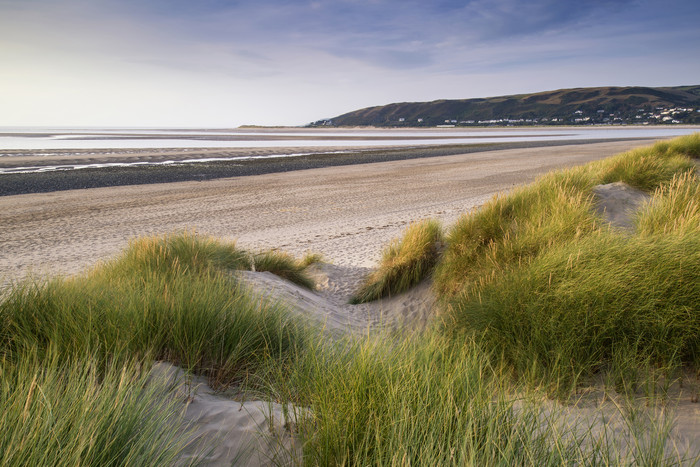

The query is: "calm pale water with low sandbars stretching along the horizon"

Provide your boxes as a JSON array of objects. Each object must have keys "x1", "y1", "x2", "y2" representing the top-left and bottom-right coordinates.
[{"x1": 0, "y1": 127, "x2": 700, "y2": 174}]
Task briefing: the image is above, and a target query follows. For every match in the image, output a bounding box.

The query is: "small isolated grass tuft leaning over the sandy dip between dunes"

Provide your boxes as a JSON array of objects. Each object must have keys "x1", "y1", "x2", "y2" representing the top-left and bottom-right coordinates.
[{"x1": 350, "y1": 220, "x2": 443, "y2": 304}]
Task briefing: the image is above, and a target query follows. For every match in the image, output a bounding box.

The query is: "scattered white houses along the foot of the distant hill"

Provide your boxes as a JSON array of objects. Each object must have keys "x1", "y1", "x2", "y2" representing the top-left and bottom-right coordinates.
[{"x1": 309, "y1": 107, "x2": 700, "y2": 128}]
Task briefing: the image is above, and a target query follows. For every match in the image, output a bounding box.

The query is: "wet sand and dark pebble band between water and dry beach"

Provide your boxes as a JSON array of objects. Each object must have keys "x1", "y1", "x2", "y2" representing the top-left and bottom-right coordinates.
[{"x1": 0, "y1": 140, "x2": 648, "y2": 196}]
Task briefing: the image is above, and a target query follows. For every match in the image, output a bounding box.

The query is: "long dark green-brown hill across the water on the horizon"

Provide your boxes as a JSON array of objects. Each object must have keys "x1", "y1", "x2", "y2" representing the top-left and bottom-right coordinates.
[{"x1": 310, "y1": 86, "x2": 700, "y2": 127}]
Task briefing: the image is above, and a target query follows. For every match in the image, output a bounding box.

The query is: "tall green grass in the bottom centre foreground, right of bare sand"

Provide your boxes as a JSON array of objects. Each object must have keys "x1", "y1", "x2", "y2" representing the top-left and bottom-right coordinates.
[{"x1": 270, "y1": 330, "x2": 696, "y2": 465}]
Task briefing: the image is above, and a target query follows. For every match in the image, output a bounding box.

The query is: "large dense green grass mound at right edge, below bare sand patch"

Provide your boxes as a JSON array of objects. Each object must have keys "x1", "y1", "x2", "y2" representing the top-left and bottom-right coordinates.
[{"x1": 448, "y1": 234, "x2": 700, "y2": 394}]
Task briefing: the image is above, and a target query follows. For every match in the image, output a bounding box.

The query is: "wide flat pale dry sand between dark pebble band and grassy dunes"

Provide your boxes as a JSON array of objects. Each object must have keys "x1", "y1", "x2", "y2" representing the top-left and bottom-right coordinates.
[{"x1": 0, "y1": 140, "x2": 650, "y2": 284}]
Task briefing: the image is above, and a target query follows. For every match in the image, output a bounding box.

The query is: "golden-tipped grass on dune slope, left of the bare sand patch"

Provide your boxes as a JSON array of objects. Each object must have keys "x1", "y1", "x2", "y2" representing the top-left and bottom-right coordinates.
[{"x1": 435, "y1": 169, "x2": 599, "y2": 296}]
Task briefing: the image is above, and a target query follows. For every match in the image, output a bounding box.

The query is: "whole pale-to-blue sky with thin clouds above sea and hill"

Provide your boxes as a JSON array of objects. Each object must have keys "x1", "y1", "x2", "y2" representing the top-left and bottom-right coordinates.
[{"x1": 0, "y1": 0, "x2": 700, "y2": 128}]
